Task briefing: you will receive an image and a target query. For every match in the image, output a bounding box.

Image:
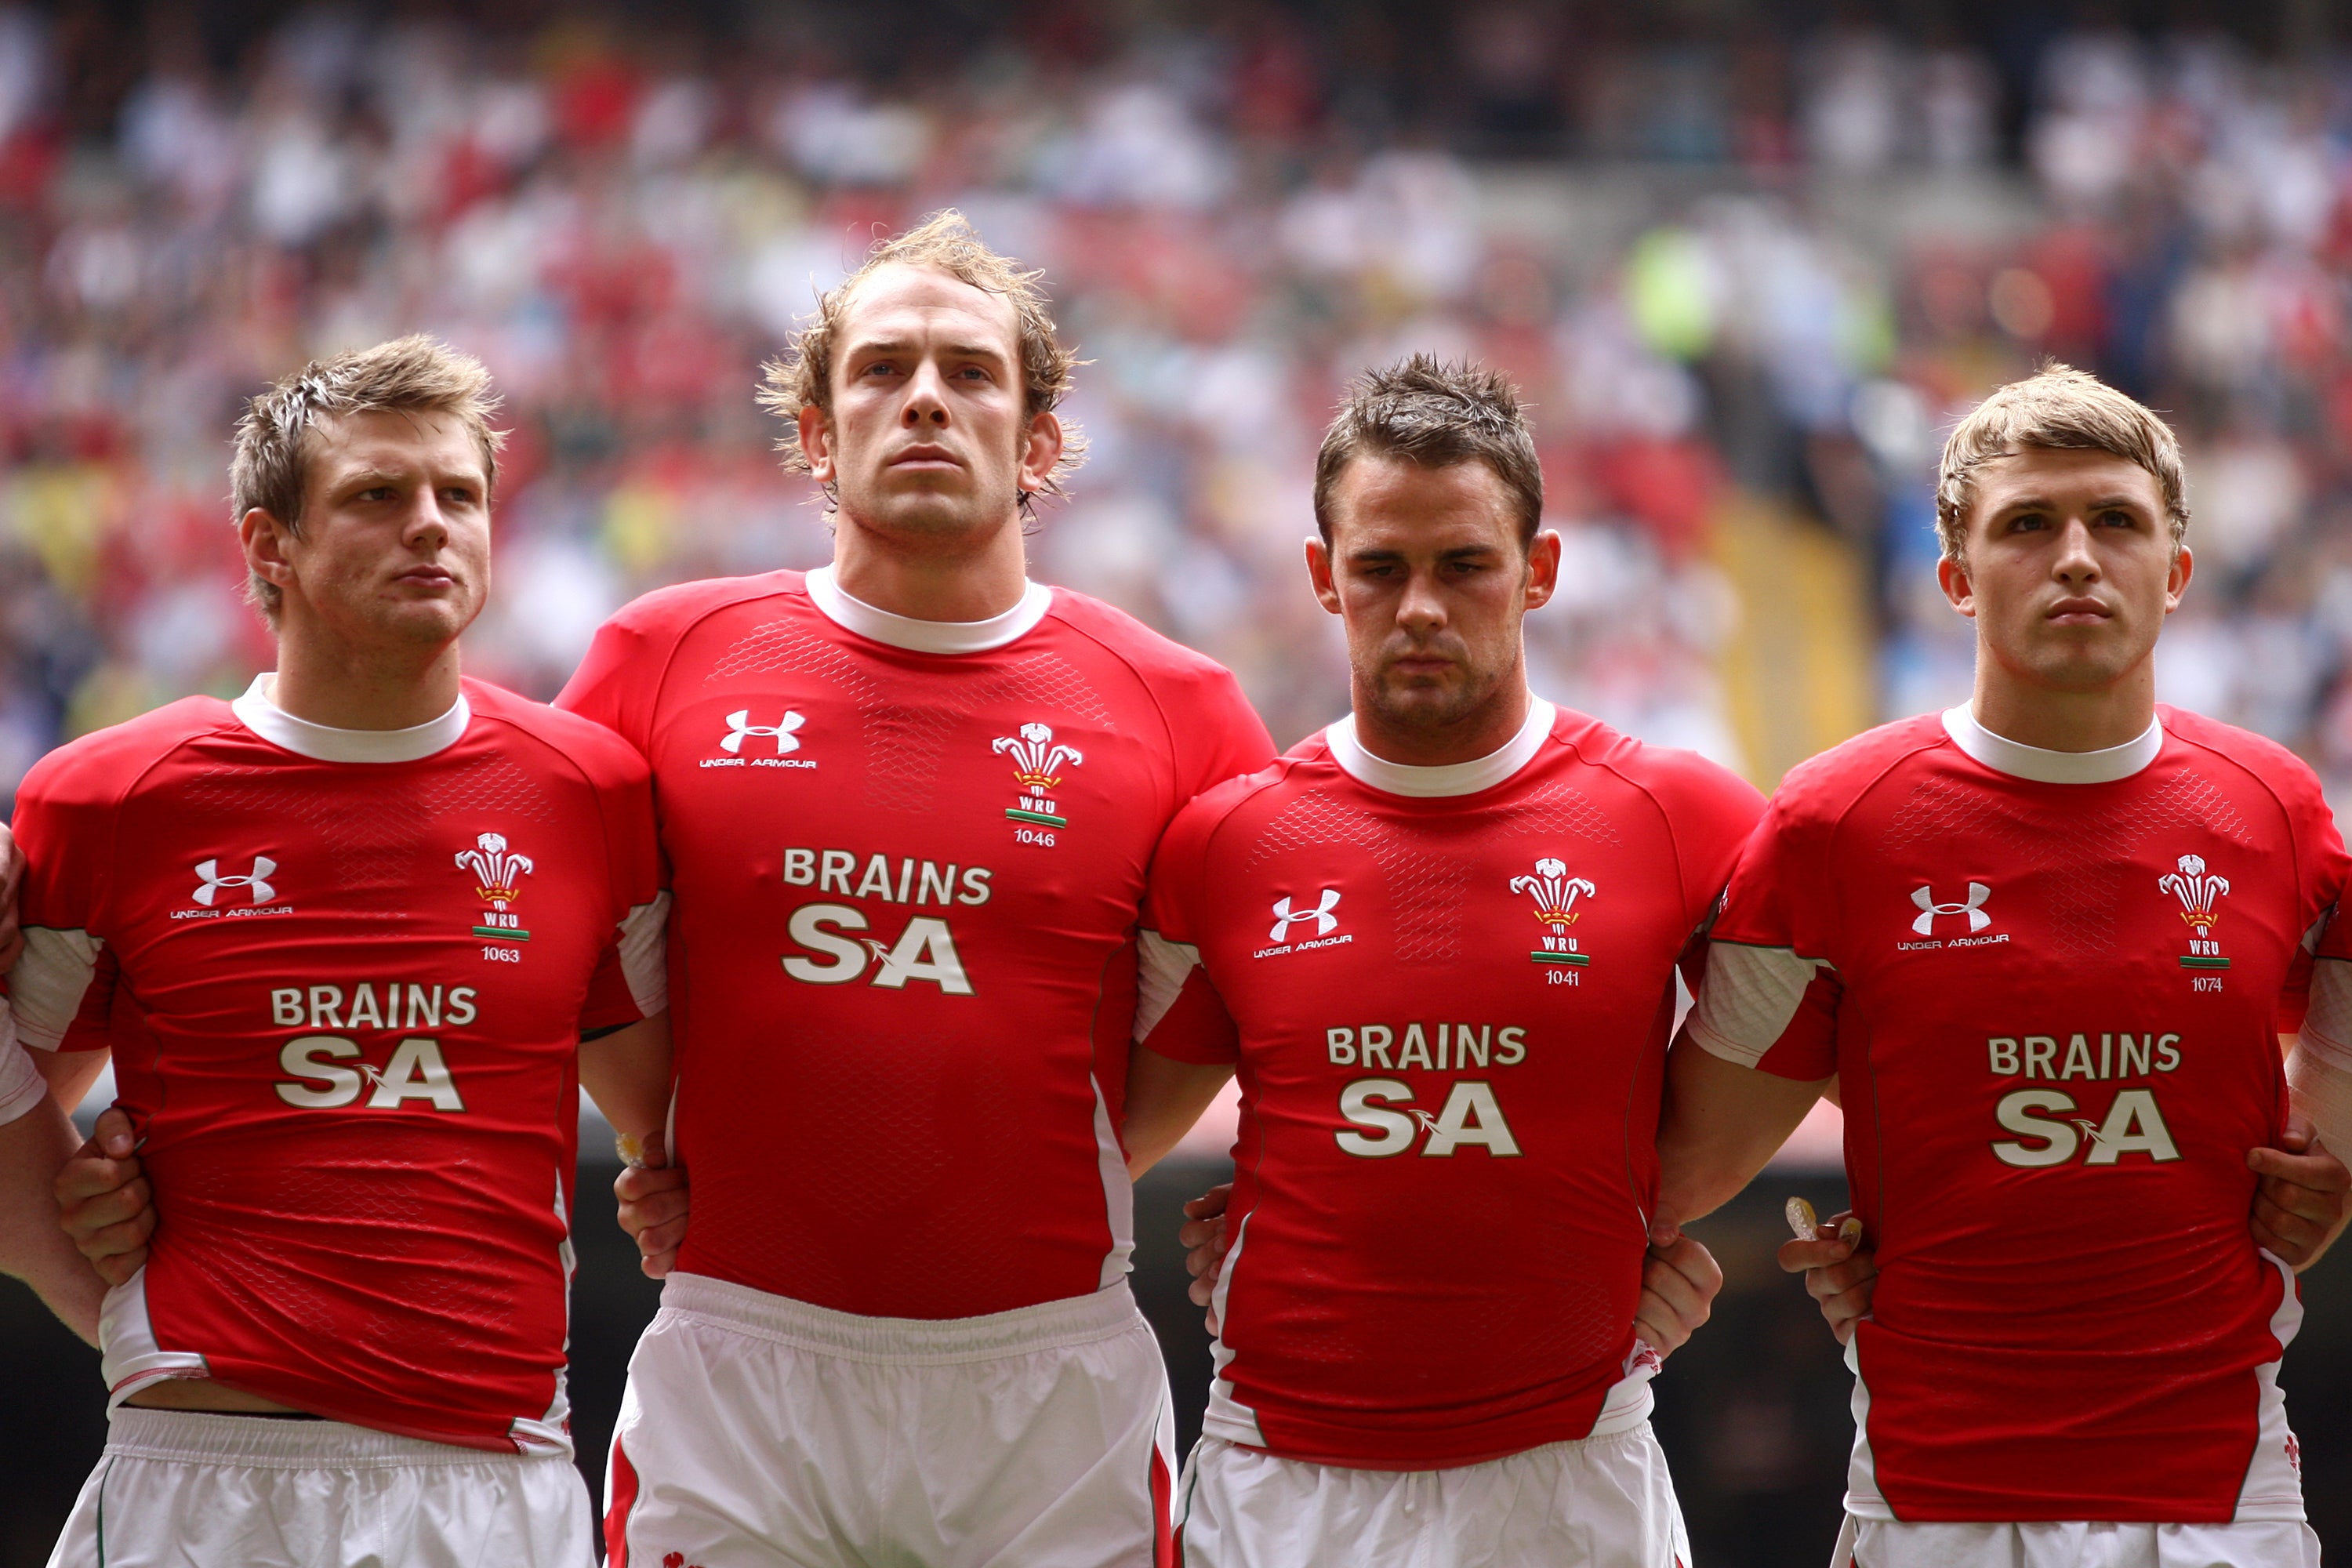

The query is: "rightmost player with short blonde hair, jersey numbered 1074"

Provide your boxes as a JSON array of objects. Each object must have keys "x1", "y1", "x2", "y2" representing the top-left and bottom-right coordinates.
[{"x1": 1661, "y1": 367, "x2": 2347, "y2": 1568}]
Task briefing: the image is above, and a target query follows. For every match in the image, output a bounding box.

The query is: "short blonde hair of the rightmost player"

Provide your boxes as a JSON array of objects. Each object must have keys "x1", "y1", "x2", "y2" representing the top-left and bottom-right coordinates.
[{"x1": 1936, "y1": 360, "x2": 2190, "y2": 562}]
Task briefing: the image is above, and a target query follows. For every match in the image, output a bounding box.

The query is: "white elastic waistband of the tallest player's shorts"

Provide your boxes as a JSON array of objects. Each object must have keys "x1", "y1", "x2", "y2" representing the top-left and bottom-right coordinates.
[{"x1": 661, "y1": 1274, "x2": 1150, "y2": 1366}]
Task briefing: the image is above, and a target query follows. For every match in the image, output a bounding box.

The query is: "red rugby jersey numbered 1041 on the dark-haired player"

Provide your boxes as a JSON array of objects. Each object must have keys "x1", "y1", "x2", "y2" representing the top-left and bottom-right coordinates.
[{"x1": 1136, "y1": 703, "x2": 1762, "y2": 1469}]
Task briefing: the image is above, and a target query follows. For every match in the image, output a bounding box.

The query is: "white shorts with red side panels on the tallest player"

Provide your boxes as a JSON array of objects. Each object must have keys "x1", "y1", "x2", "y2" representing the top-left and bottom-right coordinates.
[{"x1": 604, "y1": 1274, "x2": 1176, "y2": 1568}]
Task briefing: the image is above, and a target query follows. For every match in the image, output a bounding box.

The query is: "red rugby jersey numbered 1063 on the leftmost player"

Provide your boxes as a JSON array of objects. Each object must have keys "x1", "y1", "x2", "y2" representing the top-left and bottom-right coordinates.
[{"x1": 9, "y1": 677, "x2": 666, "y2": 1453}]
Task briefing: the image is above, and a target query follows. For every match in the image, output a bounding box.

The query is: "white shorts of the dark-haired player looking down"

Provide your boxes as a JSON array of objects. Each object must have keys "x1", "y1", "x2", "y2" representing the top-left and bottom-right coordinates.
[{"x1": 1176, "y1": 1420, "x2": 1691, "y2": 1568}]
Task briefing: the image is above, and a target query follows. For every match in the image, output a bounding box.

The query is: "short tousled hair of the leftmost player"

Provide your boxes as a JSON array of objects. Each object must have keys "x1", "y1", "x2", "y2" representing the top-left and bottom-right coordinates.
[{"x1": 228, "y1": 332, "x2": 506, "y2": 626}]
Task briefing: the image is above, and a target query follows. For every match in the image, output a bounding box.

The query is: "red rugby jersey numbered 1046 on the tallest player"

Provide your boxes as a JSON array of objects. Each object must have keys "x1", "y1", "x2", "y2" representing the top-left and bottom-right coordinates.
[{"x1": 557, "y1": 569, "x2": 1272, "y2": 1319}]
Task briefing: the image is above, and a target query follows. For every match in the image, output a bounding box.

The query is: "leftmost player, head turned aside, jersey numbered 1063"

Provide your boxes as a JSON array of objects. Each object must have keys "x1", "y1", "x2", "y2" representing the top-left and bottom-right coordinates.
[{"x1": 9, "y1": 336, "x2": 668, "y2": 1568}]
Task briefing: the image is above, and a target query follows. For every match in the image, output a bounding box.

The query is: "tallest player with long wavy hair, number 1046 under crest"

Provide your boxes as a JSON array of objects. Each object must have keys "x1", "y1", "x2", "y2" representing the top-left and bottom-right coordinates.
[{"x1": 560, "y1": 212, "x2": 1272, "y2": 1568}]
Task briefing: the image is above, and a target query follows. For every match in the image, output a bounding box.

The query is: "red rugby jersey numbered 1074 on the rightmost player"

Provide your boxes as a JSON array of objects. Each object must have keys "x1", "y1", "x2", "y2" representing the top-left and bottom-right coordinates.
[{"x1": 1691, "y1": 708, "x2": 2345, "y2": 1523}]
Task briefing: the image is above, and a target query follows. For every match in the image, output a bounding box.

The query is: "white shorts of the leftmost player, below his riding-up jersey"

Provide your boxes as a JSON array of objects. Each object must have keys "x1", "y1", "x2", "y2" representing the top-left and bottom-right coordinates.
[{"x1": 49, "y1": 1406, "x2": 595, "y2": 1568}]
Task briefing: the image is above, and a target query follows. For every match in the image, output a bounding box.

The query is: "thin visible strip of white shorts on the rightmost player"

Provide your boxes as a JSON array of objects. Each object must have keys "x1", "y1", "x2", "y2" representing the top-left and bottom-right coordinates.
[{"x1": 1830, "y1": 1514, "x2": 2319, "y2": 1568}]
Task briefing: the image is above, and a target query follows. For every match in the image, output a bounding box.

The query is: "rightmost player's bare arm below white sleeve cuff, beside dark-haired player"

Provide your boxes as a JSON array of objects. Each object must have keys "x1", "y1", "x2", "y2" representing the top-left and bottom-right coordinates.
[{"x1": 1658, "y1": 1036, "x2": 1830, "y2": 1225}]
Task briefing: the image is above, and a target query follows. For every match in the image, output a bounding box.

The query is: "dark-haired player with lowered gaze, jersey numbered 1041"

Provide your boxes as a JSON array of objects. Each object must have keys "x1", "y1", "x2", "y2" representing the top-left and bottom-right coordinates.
[{"x1": 1127, "y1": 355, "x2": 1762, "y2": 1568}]
